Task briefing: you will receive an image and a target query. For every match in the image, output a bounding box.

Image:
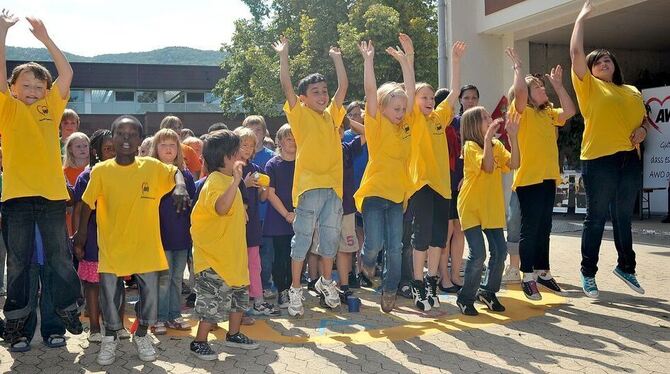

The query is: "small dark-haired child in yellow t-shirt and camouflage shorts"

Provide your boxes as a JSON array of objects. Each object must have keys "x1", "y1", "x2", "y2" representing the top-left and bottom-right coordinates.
[{"x1": 190, "y1": 130, "x2": 258, "y2": 360}]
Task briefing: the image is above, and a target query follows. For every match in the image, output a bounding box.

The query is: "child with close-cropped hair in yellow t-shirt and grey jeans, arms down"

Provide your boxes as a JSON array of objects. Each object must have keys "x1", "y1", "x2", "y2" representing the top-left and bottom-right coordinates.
[{"x1": 74, "y1": 115, "x2": 190, "y2": 365}]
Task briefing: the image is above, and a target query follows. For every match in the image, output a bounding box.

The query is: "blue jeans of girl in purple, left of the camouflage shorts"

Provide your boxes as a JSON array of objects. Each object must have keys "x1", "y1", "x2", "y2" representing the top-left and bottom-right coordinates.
[{"x1": 158, "y1": 250, "x2": 188, "y2": 322}]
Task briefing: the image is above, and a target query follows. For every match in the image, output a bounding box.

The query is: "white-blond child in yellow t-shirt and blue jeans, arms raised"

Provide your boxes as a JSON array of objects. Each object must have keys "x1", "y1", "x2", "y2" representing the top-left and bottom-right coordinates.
[{"x1": 354, "y1": 34, "x2": 414, "y2": 313}]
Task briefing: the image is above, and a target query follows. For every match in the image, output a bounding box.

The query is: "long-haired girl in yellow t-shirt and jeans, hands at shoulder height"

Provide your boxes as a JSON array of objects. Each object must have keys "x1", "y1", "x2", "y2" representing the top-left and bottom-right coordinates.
[{"x1": 456, "y1": 107, "x2": 519, "y2": 316}]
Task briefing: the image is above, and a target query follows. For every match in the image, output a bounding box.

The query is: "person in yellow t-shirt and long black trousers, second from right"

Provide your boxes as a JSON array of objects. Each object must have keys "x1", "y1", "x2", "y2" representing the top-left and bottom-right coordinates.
[{"x1": 505, "y1": 48, "x2": 575, "y2": 300}]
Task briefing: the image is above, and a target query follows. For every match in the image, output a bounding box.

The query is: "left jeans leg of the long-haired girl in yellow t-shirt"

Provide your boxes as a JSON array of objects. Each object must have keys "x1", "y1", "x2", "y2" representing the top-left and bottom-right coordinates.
[{"x1": 458, "y1": 226, "x2": 486, "y2": 304}]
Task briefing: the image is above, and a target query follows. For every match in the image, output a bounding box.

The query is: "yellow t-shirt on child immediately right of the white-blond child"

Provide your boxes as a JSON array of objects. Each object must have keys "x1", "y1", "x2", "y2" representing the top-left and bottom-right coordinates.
[{"x1": 409, "y1": 100, "x2": 454, "y2": 199}]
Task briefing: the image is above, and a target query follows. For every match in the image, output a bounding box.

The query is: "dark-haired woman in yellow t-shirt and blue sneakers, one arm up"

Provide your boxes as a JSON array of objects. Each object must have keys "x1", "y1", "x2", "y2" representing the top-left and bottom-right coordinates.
[{"x1": 570, "y1": 0, "x2": 649, "y2": 297}]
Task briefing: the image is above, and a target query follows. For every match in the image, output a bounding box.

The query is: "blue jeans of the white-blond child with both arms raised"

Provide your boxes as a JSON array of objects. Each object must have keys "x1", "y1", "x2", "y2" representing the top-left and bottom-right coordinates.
[{"x1": 361, "y1": 196, "x2": 403, "y2": 294}]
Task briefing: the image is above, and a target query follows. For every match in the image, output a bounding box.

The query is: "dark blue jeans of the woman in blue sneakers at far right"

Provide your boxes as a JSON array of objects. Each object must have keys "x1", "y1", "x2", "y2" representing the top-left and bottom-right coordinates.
[{"x1": 581, "y1": 151, "x2": 642, "y2": 277}]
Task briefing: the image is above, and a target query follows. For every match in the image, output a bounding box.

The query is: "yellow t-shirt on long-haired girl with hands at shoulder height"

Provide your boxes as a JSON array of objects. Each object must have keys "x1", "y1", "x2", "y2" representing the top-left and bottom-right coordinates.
[{"x1": 458, "y1": 139, "x2": 511, "y2": 230}]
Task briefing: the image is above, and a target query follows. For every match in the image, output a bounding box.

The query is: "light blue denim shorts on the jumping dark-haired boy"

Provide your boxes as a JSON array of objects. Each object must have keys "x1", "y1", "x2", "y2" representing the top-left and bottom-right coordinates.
[{"x1": 291, "y1": 188, "x2": 342, "y2": 261}]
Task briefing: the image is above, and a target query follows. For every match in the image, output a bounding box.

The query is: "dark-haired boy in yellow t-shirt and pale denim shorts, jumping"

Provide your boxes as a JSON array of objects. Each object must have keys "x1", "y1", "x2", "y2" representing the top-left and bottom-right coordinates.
[{"x1": 274, "y1": 37, "x2": 349, "y2": 316}]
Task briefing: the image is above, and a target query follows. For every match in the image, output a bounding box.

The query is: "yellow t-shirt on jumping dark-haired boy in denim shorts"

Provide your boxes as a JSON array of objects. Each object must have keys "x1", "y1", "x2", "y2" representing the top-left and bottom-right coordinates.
[{"x1": 284, "y1": 98, "x2": 346, "y2": 207}]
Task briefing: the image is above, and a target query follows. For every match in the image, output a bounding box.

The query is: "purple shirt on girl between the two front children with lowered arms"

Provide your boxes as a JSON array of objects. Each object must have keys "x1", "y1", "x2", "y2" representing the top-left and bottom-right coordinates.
[{"x1": 158, "y1": 169, "x2": 195, "y2": 251}]
